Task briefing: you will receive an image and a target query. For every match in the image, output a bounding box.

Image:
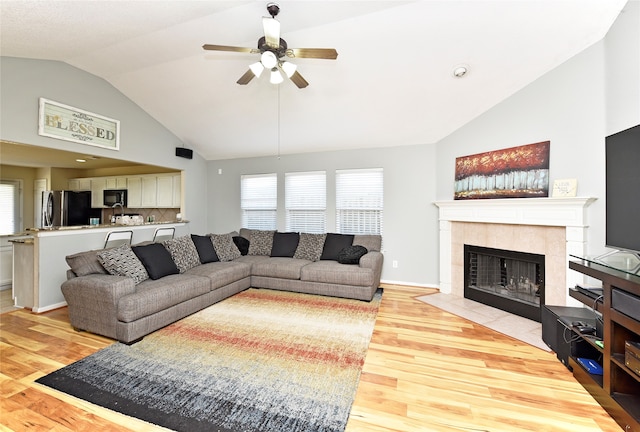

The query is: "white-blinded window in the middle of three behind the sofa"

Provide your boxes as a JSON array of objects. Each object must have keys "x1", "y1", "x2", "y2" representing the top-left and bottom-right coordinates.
[{"x1": 284, "y1": 171, "x2": 327, "y2": 234}]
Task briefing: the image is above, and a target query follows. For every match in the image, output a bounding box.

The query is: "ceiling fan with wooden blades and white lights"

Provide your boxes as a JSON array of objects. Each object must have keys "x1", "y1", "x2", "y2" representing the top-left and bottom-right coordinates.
[{"x1": 202, "y1": 3, "x2": 338, "y2": 88}]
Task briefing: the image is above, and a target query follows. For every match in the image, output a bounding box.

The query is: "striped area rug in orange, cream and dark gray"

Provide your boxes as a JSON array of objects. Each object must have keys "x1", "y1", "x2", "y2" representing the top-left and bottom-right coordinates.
[{"x1": 37, "y1": 289, "x2": 382, "y2": 432}]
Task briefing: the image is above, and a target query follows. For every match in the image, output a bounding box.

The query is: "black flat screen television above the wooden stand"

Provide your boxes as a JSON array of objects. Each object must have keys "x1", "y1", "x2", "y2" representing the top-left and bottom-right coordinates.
[{"x1": 605, "y1": 125, "x2": 640, "y2": 254}]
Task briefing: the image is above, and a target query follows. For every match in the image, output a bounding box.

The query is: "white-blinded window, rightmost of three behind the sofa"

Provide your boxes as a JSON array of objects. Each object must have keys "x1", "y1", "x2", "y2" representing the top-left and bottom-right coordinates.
[{"x1": 336, "y1": 168, "x2": 384, "y2": 234}]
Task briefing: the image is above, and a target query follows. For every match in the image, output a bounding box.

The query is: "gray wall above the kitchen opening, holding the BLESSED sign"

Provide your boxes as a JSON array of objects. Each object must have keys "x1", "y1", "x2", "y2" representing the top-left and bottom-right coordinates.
[{"x1": 0, "y1": 57, "x2": 206, "y2": 232}]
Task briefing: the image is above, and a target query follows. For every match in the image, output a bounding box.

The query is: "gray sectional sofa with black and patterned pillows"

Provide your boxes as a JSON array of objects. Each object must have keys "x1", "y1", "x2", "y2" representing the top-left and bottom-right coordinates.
[{"x1": 61, "y1": 229, "x2": 383, "y2": 343}]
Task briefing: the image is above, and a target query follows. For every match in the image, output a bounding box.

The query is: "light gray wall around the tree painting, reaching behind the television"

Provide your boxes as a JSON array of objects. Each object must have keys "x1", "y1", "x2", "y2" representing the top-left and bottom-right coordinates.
[{"x1": 436, "y1": 1, "x2": 640, "y2": 255}]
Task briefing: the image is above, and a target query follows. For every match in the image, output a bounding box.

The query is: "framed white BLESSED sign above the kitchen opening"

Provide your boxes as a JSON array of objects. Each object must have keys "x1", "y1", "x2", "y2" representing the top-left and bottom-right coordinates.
[{"x1": 38, "y1": 98, "x2": 120, "y2": 150}]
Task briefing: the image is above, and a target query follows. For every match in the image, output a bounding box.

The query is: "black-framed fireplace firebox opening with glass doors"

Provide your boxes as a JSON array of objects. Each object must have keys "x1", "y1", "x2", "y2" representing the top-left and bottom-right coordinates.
[{"x1": 464, "y1": 244, "x2": 545, "y2": 322}]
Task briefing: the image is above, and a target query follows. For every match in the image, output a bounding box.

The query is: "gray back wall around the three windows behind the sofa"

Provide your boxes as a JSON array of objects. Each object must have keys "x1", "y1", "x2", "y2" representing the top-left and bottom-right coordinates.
[{"x1": 207, "y1": 145, "x2": 438, "y2": 286}]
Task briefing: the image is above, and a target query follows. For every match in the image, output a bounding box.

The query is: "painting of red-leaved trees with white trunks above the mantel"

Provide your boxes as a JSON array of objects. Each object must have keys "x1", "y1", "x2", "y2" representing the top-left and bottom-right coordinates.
[{"x1": 454, "y1": 141, "x2": 550, "y2": 200}]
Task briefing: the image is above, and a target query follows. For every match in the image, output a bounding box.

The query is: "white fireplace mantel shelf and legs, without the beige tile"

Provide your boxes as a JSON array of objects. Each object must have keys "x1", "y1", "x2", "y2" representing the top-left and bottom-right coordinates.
[{"x1": 434, "y1": 197, "x2": 596, "y2": 302}]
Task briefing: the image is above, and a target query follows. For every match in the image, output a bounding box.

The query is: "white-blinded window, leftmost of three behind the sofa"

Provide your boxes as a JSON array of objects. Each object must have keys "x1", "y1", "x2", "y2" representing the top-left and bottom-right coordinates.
[{"x1": 240, "y1": 173, "x2": 278, "y2": 230}]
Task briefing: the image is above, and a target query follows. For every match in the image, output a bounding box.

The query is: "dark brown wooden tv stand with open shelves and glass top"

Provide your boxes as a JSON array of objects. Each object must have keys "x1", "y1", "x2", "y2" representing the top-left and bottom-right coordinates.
[{"x1": 569, "y1": 257, "x2": 640, "y2": 432}]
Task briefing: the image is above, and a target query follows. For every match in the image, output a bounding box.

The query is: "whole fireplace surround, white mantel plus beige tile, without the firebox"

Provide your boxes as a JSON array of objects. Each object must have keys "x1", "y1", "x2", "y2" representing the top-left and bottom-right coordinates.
[{"x1": 435, "y1": 197, "x2": 595, "y2": 306}]
